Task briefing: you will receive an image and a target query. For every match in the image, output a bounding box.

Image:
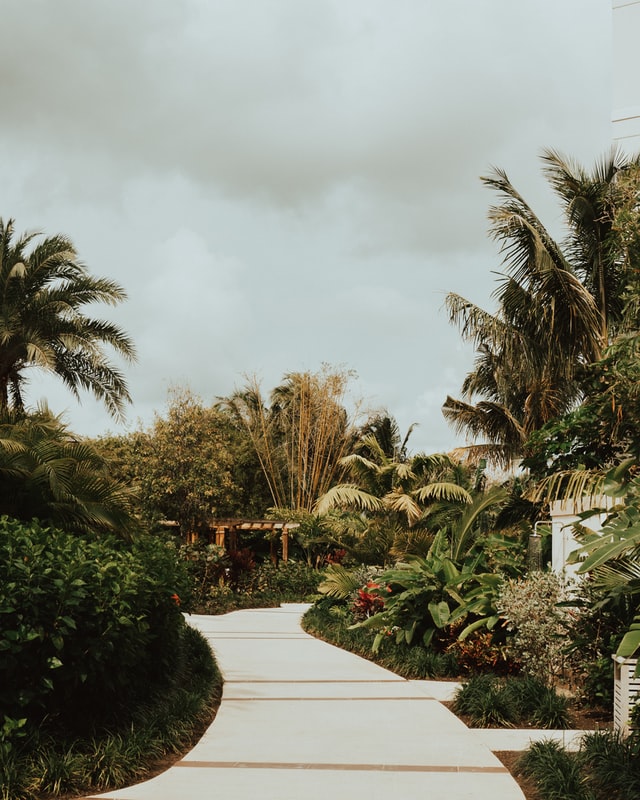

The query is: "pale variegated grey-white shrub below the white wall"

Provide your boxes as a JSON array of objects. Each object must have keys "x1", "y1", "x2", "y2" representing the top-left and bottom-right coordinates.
[{"x1": 498, "y1": 572, "x2": 567, "y2": 685}]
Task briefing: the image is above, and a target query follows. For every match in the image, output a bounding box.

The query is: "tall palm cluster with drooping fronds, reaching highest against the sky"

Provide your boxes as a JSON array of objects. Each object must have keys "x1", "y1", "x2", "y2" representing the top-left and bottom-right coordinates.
[{"x1": 443, "y1": 150, "x2": 640, "y2": 466}]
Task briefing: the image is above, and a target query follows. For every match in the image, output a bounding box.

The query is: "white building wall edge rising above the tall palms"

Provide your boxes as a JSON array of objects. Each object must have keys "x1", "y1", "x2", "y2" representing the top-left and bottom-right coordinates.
[{"x1": 611, "y1": 0, "x2": 640, "y2": 154}]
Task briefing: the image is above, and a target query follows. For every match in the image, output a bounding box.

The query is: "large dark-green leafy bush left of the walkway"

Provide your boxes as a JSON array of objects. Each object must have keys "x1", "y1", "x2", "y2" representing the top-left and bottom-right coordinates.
[{"x1": 0, "y1": 517, "x2": 189, "y2": 738}]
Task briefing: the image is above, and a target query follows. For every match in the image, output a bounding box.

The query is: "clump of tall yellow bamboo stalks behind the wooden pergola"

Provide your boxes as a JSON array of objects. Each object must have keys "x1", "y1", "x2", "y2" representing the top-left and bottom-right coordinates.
[{"x1": 221, "y1": 367, "x2": 355, "y2": 511}]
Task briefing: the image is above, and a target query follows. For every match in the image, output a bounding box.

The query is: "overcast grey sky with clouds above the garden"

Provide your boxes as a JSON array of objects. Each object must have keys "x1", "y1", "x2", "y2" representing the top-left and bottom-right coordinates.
[{"x1": 0, "y1": 0, "x2": 612, "y2": 452}]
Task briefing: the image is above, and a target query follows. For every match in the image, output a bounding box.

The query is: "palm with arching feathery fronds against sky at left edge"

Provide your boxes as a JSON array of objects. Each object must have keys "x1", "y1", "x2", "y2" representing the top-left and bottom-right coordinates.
[{"x1": 0, "y1": 219, "x2": 135, "y2": 417}]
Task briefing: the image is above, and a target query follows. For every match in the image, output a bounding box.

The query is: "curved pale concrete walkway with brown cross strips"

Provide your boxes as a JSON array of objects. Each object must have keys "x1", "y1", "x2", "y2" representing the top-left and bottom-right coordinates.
[{"x1": 91, "y1": 605, "x2": 524, "y2": 800}]
